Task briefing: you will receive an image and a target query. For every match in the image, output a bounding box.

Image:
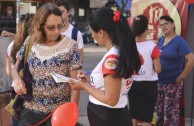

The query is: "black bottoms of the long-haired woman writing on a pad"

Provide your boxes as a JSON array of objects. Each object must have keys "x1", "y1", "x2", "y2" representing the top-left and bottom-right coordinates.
[{"x1": 87, "y1": 102, "x2": 132, "y2": 126}]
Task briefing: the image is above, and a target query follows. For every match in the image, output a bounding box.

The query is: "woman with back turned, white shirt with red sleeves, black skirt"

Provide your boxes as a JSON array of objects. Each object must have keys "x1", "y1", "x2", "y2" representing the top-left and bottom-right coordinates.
[{"x1": 128, "y1": 15, "x2": 161, "y2": 126}]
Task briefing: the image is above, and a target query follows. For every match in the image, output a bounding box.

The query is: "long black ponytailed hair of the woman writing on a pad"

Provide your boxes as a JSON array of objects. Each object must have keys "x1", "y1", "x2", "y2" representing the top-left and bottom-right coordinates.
[{"x1": 89, "y1": 7, "x2": 141, "y2": 78}]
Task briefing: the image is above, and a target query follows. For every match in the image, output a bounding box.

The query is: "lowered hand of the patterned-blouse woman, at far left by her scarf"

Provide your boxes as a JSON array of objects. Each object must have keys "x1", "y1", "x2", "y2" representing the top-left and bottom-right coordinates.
[{"x1": 13, "y1": 79, "x2": 27, "y2": 95}]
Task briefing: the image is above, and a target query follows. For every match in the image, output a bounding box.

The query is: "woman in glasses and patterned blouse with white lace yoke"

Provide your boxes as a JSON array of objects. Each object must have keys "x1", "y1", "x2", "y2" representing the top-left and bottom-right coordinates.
[{"x1": 12, "y1": 3, "x2": 81, "y2": 126}]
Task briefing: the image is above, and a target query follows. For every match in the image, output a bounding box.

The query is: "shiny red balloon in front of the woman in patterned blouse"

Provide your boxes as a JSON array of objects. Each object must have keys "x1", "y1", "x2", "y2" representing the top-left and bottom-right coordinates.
[{"x1": 51, "y1": 102, "x2": 78, "y2": 126}]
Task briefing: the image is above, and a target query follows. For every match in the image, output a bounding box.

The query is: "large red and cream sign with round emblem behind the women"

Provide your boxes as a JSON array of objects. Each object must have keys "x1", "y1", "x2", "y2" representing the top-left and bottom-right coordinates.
[{"x1": 131, "y1": 0, "x2": 188, "y2": 41}]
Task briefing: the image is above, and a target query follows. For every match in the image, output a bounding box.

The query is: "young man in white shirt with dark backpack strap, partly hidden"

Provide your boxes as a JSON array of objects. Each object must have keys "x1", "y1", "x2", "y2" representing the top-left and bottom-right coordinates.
[{"x1": 55, "y1": 0, "x2": 84, "y2": 62}]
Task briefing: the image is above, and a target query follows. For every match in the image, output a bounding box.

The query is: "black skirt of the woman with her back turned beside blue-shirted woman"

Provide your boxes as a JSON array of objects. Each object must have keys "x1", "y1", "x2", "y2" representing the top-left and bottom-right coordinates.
[{"x1": 128, "y1": 81, "x2": 158, "y2": 123}]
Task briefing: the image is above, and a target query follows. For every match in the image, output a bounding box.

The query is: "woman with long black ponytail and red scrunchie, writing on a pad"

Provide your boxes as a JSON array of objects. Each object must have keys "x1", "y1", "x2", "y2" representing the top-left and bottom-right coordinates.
[{"x1": 69, "y1": 7, "x2": 141, "y2": 126}]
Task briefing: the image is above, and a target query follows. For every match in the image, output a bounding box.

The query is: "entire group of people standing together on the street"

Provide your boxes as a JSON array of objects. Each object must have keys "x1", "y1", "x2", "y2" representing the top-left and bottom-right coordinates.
[{"x1": 1, "y1": 0, "x2": 194, "y2": 126}]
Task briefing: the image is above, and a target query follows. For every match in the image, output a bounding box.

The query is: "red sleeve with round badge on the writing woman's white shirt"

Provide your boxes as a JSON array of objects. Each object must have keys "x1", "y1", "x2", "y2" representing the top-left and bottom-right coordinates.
[{"x1": 102, "y1": 54, "x2": 118, "y2": 76}]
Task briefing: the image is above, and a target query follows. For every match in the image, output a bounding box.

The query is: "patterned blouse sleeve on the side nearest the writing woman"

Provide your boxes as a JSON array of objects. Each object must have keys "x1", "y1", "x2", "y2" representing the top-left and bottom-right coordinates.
[{"x1": 69, "y1": 43, "x2": 82, "y2": 70}]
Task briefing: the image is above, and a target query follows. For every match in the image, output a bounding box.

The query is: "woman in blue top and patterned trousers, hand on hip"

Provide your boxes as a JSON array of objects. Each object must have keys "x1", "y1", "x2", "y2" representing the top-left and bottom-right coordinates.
[{"x1": 156, "y1": 16, "x2": 194, "y2": 126}]
